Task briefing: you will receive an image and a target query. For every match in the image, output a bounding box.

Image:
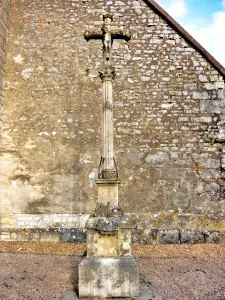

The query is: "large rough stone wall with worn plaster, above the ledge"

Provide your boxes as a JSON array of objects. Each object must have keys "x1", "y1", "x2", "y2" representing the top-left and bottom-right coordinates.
[{"x1": 0, "y1": 0, "x2": 225, "y2": 216}]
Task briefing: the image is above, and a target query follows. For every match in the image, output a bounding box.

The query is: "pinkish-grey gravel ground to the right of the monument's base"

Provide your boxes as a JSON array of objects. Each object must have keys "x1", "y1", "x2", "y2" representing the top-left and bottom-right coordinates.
[{"x1": 140, "y1": 258, "x2": 225, "y2": 300}]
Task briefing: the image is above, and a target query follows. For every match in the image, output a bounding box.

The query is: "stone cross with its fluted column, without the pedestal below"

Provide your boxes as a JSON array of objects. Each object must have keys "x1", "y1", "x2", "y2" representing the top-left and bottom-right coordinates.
[{"x1": 84, "y1": 14, "x2": 131, "y2": 179}]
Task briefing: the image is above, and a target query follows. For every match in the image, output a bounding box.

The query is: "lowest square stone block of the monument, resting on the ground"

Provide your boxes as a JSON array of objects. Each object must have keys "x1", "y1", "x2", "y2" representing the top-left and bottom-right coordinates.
[{"x1": 79, "y1": 256, "x2": 139, "y2": 298}]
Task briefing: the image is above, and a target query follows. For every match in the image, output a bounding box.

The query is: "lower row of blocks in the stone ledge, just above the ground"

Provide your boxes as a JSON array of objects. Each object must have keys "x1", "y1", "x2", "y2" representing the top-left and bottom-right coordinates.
[{"x1": 0, "y1": 228, "x2": 225, "y2": 245}]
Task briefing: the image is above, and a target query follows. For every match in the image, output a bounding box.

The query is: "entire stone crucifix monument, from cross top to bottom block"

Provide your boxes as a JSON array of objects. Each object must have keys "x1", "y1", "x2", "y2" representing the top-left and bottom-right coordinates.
[{"x1": 79, "y1": 14, "x2": 139, "y2": 299}]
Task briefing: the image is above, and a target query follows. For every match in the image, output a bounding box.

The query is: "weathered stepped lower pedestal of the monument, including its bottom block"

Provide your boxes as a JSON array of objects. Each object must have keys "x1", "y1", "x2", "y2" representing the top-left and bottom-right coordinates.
[{"x1": 79, "y1": 214, "x2": 139, "y2": 298}]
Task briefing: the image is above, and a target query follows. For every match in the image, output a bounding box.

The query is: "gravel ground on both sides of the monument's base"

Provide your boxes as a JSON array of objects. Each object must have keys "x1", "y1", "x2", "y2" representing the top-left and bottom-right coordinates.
[{"x1": 0, "y1": 245, "x2": 225, "y2": 300}]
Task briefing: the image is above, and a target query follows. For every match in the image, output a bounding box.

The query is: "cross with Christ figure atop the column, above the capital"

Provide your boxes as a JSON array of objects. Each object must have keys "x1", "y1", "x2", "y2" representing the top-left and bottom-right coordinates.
[{"x1": 84, "y1": 14, "x2": 131, "y2": 67}]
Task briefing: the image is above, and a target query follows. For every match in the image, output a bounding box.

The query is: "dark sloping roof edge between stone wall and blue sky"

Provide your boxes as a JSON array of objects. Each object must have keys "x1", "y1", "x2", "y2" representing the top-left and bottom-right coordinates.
[{"x1": 143, "y1": 0, "x2": 225, "y2": 79}]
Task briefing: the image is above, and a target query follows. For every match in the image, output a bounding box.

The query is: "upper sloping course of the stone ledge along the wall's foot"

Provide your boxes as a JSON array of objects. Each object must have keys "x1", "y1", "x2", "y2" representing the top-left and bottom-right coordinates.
[{"x1": 0, "y1": 212, "x2": 225, "y2": 232}]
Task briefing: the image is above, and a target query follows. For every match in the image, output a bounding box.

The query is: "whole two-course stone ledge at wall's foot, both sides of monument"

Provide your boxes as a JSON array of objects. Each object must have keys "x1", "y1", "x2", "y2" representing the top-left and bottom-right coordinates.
[{"x1": 0, "y1": 212, "x2": 225, "y2": 245}]
